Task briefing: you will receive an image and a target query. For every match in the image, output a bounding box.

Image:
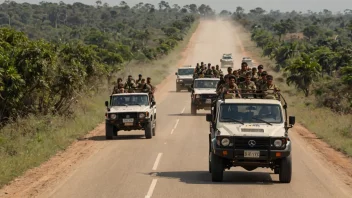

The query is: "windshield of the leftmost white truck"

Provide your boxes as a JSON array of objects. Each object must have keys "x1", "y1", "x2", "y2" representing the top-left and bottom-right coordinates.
[{"x1": 111, "y1": 95, "x2": 149, "y2": 106}]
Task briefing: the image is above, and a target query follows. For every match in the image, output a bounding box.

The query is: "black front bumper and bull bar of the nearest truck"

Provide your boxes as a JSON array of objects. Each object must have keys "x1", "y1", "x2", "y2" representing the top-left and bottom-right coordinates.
[{"x1": 212, "y1": 137, "x2": 291, "y2": 162}]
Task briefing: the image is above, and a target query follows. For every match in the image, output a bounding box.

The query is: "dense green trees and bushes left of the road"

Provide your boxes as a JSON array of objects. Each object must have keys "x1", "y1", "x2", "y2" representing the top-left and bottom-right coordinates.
[{"x1": 0, "y1": 0, "x2": 215, "y2": 123}]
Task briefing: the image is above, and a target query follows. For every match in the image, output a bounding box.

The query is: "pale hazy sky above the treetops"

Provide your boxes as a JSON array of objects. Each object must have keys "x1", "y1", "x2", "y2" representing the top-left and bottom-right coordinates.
[{"x1": 6, "y1": 0, "x2": 352, "y2": 13}]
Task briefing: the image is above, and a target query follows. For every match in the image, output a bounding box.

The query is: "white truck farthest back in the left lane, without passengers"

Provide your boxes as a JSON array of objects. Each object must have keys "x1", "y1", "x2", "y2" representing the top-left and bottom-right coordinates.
[{"x1": 175, "y1": 65, "x2": 195, "y2": 92}]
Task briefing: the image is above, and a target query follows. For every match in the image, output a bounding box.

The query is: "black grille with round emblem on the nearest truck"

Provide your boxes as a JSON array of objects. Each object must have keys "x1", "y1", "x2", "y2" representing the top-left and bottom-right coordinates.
[{"x1": 234, "y1": 137, "x2": 270, "y2": 150}]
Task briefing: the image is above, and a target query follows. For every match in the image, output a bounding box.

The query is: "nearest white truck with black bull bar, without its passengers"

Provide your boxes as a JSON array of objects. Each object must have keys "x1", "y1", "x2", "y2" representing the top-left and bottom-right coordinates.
[{"x1": 206, "y1": 93, "x2": 295, "y2": 183}]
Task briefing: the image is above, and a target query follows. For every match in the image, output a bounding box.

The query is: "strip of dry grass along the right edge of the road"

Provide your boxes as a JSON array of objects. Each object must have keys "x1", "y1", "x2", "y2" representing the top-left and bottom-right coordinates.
[{"x1": 235, "y1": 24, "x2": 352, "y2": 157}]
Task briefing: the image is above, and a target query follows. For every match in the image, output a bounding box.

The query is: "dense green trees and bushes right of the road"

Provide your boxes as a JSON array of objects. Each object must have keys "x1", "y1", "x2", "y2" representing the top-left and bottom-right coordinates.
[{"x1": 220, "y1": 7, "x2": 352, "y2": 113}]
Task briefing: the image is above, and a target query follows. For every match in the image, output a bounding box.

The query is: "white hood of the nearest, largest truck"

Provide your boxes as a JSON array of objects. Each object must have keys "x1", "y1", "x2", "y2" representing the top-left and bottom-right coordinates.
[{"x1": 217, "y1": 123, "x2": 285, "y2": 137}]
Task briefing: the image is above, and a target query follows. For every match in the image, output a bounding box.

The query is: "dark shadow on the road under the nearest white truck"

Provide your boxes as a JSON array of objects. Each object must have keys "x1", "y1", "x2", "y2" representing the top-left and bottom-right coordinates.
[{"x1": 146, "y1": 171, "x2": 279, "y2": 185}]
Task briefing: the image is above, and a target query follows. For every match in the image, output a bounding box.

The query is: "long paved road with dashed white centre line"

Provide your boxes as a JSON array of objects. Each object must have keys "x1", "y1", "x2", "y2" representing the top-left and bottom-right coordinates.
[{"x1": 2, "y1": 21, "x2": 352, "y2": 198}]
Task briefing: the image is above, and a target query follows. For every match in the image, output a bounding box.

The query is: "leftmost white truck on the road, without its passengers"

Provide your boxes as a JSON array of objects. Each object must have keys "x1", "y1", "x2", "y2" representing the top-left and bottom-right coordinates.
[{"x1": 105, "y1": 93, "x2": 156, "y2": 140}]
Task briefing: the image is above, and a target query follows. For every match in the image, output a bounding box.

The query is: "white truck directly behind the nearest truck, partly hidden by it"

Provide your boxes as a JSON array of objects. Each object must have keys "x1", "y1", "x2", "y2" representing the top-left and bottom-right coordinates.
[{"x1": 191, "y1": 78, "x2": 220, "y2": 115}]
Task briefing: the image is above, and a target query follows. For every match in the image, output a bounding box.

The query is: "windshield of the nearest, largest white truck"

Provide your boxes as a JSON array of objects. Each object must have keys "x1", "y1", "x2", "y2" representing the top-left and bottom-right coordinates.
[{"x1": 219, "y1": 104, "x2": 283, "y2": 123}]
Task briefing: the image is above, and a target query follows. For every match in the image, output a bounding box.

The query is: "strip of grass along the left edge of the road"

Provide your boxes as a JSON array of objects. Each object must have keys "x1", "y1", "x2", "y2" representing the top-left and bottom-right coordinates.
[{"x1": 0, "y1": 21, "x2": 199, "y2": 187}]
